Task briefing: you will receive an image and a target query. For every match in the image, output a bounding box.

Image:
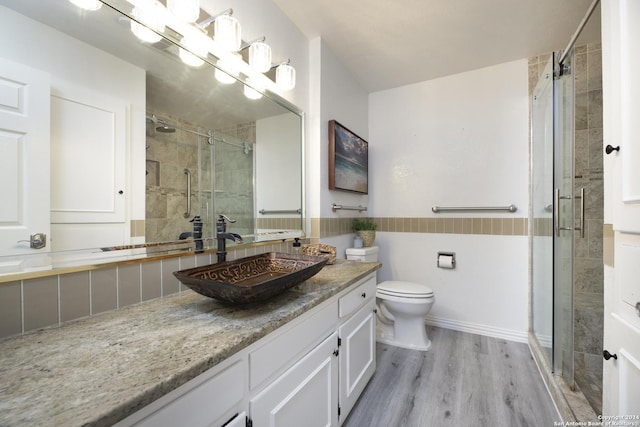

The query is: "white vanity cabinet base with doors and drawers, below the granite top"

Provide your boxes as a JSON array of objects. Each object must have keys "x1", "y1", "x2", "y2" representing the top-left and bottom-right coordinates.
[{"x1": 117, "y1": 273, "x2": 376, "y2": 427}]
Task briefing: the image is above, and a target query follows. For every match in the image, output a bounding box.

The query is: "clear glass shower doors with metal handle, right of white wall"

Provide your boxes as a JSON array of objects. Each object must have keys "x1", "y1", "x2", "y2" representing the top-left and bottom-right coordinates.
[{"x1": 531, "y1": 52, "x2": 576, "y2": 388}]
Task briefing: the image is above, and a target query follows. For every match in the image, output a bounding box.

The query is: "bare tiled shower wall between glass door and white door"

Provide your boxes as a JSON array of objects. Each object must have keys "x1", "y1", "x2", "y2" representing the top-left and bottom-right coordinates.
[{"x1": 574, "y1": 43, "x2": 604, "y2": 414}]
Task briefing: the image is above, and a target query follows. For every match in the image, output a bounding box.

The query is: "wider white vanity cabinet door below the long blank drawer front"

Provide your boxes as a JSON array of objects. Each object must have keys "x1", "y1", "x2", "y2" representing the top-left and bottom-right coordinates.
[{"x1": 249, "y1": 332, "x2": 338, "y2": 427}]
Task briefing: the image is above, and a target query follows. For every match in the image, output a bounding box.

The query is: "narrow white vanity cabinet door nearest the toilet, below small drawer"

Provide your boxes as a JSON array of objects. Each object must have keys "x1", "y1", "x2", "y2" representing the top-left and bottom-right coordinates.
[{"x1": 339, "y1": 299, "x2": 376, "y2": 423}]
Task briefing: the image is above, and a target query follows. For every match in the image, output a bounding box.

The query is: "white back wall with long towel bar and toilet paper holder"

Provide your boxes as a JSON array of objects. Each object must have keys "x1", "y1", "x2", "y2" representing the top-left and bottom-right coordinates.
[{"x1": 369, "y1": 60, "x2": 529, "y2": 342}]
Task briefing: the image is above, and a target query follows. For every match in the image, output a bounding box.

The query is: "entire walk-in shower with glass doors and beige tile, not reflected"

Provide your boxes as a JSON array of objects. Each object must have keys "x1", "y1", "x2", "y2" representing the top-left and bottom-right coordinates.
[{"x1": 530, "y1": 5, "x2": 604, "y2": 421}]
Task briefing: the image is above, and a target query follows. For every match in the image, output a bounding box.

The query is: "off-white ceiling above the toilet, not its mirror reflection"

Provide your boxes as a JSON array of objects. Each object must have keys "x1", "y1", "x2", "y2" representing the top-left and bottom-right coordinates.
[{"x1": 273, "y1": 0, "x2": 600, "y2": 92}]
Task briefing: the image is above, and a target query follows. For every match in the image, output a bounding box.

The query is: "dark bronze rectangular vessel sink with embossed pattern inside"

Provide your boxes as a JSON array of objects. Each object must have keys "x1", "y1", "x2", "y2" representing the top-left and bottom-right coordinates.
[{"x1": 173, "y1": 252, "x2": 327, "y2": 303}]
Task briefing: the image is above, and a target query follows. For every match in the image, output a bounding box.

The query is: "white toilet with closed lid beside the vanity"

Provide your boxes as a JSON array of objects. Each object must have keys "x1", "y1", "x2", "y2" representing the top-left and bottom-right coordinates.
[{"x1": 347, "y1": 246, "x2": 435, "y2": 351}]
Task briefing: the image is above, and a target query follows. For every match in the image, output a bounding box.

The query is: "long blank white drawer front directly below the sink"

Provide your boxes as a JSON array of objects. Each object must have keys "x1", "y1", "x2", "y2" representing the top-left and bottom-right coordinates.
[{"x1": 249, "y1": 302, "x2": 338, "y2": 390}]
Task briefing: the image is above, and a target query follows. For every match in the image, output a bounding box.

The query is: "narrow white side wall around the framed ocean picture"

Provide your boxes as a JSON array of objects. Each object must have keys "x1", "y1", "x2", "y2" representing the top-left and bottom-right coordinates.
[{"x1": 307, "y1": 38, "x2": 371, "y2": 257}]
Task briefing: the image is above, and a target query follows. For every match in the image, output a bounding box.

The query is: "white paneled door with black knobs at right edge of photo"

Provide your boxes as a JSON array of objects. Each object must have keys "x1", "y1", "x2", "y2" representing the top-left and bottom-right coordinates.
[{"x1": 602, "y1": 0, "x2": 640, "y2": 414}]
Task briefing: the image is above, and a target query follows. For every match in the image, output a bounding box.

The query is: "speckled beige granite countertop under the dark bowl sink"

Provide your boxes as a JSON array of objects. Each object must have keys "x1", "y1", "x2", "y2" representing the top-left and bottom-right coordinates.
[{"x1": 0, "y1": 261, "x2": 380, "y2": 427}]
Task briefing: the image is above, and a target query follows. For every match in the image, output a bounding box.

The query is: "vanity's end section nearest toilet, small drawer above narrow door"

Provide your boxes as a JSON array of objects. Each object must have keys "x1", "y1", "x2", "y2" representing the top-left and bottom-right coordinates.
[{"x1": 338, "y1": 275, "x2": 376, "y2": 424}]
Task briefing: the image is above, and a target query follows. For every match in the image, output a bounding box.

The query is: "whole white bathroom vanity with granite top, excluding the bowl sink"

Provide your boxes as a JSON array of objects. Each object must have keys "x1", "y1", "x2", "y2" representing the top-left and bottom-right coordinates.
[{"x1": 0, "y1": 261, "x2": 380, "y2": 426}]
